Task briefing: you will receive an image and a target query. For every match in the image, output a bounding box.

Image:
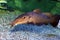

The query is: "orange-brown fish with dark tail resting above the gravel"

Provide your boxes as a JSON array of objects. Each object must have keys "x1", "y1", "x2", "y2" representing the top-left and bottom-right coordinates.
[{"x1": 10, "y1": 11, "x2": 60, "y2": 27}]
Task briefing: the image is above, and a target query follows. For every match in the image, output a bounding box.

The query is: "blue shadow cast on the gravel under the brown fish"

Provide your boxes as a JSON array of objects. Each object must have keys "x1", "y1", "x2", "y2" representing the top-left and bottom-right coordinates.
[{"x1": 10, "y1": 24, "x2": 60, "y2": 35}]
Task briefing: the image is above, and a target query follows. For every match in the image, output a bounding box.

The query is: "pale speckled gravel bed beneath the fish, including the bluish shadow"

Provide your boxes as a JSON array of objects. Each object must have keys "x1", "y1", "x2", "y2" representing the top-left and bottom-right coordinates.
[{"x1": 0, "y1": 13, "x2": 60, "y2": 40}]
